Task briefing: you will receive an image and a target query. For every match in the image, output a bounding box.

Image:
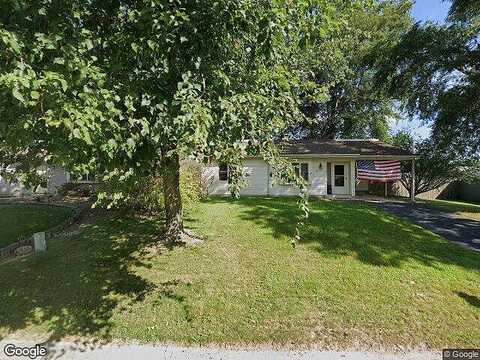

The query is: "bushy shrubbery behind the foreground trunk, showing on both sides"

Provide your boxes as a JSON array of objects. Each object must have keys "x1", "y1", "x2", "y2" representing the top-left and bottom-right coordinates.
[{"x1": 97, "y1": 161, "x2": 204, "y2": 214}]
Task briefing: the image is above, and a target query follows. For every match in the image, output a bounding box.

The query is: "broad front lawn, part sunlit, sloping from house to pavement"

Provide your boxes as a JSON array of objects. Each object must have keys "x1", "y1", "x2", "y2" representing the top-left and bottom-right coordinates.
[{"x1": 0, "y1": 198, "x2": 480, "y2": 349}]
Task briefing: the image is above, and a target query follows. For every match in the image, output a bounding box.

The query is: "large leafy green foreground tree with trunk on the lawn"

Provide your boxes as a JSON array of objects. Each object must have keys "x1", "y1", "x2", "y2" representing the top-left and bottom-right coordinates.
[{"x1": 0, "y1": 0, "x2": 348, "y2": 241}]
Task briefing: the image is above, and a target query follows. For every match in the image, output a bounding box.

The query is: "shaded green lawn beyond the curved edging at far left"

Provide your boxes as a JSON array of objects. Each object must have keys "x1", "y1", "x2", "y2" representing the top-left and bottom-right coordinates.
[{"x1": 0, "y1": 203, "x2": 72, "y2": 248}]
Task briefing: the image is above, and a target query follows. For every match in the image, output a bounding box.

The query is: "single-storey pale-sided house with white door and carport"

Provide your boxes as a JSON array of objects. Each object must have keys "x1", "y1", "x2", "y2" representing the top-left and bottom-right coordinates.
[{"x1": 203, "y1": 139, "x2": 415, "y2": 200}]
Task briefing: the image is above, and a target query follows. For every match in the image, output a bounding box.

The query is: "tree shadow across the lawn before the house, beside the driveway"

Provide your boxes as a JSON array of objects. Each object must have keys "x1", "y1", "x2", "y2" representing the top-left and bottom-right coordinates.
[{"x1": 209, "y1": 197, "x2": 480, "y2": 271}]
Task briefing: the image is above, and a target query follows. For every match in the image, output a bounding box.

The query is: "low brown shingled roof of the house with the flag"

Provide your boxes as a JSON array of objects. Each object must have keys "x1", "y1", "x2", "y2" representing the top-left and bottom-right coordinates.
[{"x1": 279, "y1": 139, "x2": 414, "y2": 157}]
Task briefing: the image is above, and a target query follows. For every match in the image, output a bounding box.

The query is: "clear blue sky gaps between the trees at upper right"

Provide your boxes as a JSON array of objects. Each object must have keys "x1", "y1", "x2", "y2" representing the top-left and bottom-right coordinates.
[{"x1": 392, "y1": 0, "x2": 450, "y2": 139}]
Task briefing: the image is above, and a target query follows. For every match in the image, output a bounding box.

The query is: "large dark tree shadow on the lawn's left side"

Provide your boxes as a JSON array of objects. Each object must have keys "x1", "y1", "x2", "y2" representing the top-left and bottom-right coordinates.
[{"x1": 0, "y1": 211, "x2": 161, "y2": 348}]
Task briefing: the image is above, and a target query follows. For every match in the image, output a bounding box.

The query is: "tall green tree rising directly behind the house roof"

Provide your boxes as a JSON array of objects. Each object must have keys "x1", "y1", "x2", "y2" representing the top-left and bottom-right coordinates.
[{"x1": 287, "y1": 0, "x2": 412, "y2": 139}]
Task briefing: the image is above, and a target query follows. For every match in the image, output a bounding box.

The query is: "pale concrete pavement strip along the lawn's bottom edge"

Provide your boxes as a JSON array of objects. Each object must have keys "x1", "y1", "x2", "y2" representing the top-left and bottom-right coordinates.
[{"x1": 0, "y1": 341, "x2": 442, "y2": 360}]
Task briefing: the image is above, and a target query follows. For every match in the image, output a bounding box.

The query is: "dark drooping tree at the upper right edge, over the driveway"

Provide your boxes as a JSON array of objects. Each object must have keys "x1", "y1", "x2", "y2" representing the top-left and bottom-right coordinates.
[{"x1": 377, "y1": 0, "x2": 480, "y2": 156}]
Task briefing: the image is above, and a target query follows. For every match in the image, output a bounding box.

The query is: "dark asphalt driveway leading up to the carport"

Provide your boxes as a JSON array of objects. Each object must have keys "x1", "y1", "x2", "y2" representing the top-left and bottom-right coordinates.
[{"x1": 375, "y1": 201, "x2": 480, "y2": 252}]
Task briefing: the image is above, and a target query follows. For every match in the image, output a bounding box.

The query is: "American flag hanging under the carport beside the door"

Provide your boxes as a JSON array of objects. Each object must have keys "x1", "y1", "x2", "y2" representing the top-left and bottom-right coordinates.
[{"x1": 357, "y1": 160, "x2": 402, "y2": 182}]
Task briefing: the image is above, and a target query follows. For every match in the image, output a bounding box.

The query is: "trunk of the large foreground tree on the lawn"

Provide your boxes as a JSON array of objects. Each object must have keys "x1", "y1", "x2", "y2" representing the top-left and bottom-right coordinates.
[{"x1": 162, "y1": 154, "x2": 183, "y2": 243}]
